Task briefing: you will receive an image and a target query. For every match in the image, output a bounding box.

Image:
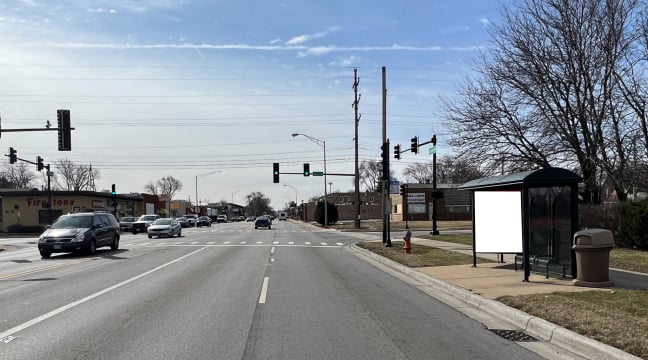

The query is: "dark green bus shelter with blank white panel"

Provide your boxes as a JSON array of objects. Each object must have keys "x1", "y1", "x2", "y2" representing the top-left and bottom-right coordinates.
[{"x1": 459, "y1": 168, "x2": 582, "y2": 281}]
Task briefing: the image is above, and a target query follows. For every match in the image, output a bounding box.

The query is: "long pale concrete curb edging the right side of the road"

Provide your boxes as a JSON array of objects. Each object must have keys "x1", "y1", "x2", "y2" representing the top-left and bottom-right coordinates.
[{"x1": 347, "y1": 245, "x2": 641, "y2": 360}]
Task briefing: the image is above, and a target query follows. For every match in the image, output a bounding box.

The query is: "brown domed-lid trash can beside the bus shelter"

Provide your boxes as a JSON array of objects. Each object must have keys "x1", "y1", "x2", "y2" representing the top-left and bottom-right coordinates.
[{"x1": 572, "y1": 229, "x2": 614, "y2": 287}]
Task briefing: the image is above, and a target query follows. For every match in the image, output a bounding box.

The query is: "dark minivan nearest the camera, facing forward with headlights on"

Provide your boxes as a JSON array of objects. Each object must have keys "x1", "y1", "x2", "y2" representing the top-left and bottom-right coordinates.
[{"x1": 38, "y1": 212, "x2": 120, "y2": 258}]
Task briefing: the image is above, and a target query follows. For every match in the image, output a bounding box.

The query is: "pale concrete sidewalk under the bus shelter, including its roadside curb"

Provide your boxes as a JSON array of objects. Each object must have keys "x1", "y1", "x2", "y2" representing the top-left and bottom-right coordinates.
[{"x1": 302, "y1": 225, "x2": 648, "y2": 360}]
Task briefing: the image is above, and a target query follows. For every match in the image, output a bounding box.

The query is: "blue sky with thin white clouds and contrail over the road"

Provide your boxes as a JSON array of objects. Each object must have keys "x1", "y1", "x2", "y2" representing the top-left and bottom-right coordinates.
[{"x1": 0, "y1": 0, "x2": 500, "y2": 210}]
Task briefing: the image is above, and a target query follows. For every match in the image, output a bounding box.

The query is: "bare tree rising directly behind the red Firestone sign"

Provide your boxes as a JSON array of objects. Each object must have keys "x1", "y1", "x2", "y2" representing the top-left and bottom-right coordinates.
[{"x1": 53, "y1": 159, "x2": 101, "y2": 191}]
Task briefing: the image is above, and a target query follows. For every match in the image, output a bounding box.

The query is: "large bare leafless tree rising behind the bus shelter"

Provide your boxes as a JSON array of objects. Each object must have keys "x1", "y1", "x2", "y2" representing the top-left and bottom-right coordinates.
[{"x1": 444, "y1": 0, "x2": 639, "y2": 203}]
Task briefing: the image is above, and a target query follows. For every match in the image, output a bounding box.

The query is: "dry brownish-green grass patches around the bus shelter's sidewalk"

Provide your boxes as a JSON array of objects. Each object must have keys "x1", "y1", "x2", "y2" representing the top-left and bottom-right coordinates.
[{"x1": 358, "y1": 238, "x2": 648, "y2": 359}]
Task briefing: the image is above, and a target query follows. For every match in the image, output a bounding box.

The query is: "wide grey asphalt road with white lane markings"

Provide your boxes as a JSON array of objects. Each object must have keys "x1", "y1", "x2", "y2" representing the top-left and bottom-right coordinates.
[{"x1": 0, "y1": 221, "x2": 540, "y2": 360}]
